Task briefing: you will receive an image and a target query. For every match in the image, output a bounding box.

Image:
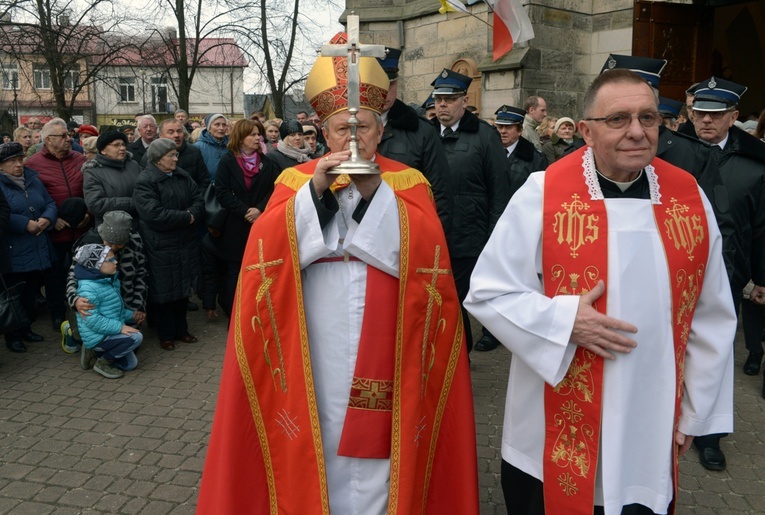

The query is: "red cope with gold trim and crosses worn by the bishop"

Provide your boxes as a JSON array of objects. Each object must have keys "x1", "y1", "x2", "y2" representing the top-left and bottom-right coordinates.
[{"x1": 197, "y1": 155, "x2": 478, "y2": 515}]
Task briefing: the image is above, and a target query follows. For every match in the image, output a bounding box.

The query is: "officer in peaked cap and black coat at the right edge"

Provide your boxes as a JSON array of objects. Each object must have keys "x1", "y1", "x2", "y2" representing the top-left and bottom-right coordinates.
[{"x1": 692, "y1": 77, "x2": 765, "y2": 470}]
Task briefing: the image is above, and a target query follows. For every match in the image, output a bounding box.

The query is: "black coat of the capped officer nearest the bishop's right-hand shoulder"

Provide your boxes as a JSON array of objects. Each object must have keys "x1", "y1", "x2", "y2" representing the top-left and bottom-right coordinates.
[{"x1": 432, "y1": 111, "x2": 510, "y2": 258}]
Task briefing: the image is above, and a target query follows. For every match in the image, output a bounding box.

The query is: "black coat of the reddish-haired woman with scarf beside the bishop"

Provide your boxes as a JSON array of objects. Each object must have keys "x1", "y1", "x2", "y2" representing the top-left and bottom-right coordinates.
[{"x1": 214, "y1": 152, "x2": 280, "y2": 261}]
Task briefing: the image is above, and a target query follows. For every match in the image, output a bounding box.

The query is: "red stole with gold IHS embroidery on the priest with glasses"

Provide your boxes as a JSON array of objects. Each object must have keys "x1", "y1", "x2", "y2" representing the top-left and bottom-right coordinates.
[{"x1": 542, "y1": 147, "x2": 709, "y2": 515}]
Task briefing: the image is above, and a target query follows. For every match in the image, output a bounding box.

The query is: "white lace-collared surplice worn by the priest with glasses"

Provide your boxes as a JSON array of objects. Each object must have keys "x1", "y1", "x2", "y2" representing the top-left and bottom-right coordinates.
[{"x1": 465, "y1": 167, "x2": 736, "y2": 515}]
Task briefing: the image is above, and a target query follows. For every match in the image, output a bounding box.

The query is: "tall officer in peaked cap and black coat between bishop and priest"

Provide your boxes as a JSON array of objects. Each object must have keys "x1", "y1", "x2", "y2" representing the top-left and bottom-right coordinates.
[{"x1": 431, "y1": 69, "x2": 510, "y2": 351}]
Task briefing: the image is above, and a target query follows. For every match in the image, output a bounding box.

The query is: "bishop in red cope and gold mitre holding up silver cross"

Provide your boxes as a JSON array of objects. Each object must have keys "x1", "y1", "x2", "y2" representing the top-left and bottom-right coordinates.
[{"x1": 198, "y1": 34, "x2": 478, "y2": 515}]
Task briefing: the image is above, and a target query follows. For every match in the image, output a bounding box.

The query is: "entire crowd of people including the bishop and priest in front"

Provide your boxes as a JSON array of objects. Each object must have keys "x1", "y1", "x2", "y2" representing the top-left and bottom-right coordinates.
[{"x1": 0, "y1": 34, "x2": 765, "y2": 514}]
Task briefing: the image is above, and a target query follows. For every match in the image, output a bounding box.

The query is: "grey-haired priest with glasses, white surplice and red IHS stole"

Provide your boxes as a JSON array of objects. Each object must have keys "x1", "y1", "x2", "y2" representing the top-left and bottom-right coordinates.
[{"x1": 466, "y1": 70, "x2": 736, "y2": 515}]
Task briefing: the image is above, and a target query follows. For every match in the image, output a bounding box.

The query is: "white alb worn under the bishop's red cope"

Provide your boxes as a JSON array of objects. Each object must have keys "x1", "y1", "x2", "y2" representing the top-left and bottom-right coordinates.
[{"x1": 295, "y1": 182, "x2": 401, "y2": 515}]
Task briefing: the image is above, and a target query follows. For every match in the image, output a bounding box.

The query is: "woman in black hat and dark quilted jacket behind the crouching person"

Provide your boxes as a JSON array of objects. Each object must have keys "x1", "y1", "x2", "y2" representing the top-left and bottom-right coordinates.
[{"x1": 82, "y1": 131, "x2": 141, "y2": 228}]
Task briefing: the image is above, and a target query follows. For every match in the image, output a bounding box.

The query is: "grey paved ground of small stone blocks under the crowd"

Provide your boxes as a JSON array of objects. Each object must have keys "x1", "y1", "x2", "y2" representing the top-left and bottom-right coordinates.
[{"x1": 0, "y1": 304, "x2": 765, "y2": 515}]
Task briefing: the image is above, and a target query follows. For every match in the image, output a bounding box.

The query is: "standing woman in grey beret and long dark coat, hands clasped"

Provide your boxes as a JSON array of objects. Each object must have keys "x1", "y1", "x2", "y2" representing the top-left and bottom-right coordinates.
[{"x1": 133, "y1": 138, "x2": 204, "y2": 350}]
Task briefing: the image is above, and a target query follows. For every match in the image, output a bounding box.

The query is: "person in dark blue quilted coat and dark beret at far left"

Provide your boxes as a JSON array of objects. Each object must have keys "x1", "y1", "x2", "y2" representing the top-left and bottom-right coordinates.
[{"x1": 0, "y1": 143, "x2": 58, "y2": 352}]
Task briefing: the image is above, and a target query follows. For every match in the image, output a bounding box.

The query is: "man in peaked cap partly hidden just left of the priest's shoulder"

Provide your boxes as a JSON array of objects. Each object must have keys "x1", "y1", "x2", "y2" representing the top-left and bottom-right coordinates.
[{"x1": 475, "y1": 105, "x2": 547, "y2": 351}]
